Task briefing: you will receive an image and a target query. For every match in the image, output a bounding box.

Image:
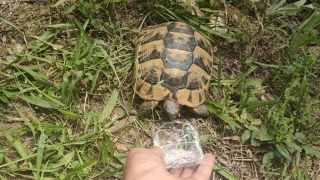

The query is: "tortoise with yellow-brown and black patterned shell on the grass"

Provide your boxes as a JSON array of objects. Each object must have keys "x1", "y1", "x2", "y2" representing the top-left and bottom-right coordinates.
[{"x1": 133, "y1": 22, "x2": 213, "y2": 119}]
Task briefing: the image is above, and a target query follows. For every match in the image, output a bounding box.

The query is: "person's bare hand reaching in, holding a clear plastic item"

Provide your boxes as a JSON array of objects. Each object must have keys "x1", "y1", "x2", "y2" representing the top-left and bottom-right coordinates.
[{"x1": 122, "y1": 146, "x2": 214, "y2": 180}]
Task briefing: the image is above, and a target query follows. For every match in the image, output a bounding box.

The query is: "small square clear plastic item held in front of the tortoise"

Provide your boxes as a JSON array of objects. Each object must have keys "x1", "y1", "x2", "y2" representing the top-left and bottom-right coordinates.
[{"x1": 153, "y1": 118, "x2": 204, "y2": 168}]
